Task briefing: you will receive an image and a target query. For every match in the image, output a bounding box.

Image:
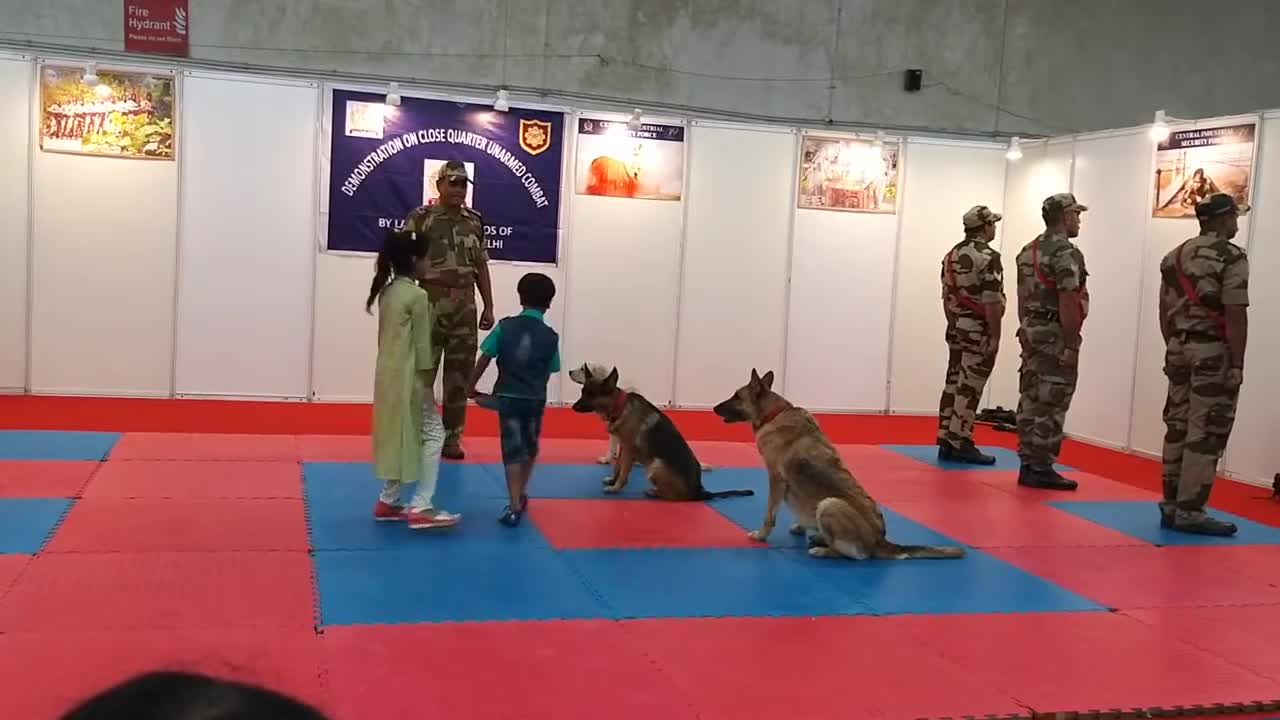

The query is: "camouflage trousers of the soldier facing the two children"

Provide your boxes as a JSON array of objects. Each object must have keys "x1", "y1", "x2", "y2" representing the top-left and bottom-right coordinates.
[{"x1": 430, "y1": 292, "x2": 480, "y2": 447}]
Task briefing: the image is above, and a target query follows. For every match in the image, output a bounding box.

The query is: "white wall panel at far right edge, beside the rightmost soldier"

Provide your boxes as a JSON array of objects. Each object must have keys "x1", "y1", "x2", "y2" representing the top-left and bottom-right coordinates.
[{"x1": 1225, "y1": 114, "x2": 1280, "y2": 483}]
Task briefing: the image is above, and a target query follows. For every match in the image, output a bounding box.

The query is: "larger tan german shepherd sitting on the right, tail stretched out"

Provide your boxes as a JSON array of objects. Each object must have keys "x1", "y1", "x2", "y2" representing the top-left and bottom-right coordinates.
[{"x1": 714, "y1": 369, "x2": 965, "y2": 560}]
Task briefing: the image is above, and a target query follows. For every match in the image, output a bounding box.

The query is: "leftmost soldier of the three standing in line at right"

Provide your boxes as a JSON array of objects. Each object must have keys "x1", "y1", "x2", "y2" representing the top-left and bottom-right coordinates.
[{"x1": 938, "y1": 205, "x2": 1005, "y2": 465}]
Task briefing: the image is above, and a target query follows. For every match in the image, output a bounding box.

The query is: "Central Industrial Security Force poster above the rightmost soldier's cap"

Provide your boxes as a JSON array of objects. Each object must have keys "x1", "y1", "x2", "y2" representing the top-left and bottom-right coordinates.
[{"x1": 1151, "y1": 123, "x2": 1257, "y2": 218}]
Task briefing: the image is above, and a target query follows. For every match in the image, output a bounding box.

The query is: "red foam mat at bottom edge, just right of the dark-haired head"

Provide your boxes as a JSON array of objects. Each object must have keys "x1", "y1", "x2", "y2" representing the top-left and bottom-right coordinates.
[{"x1": 323, "y1": 617, "x2": 701, "y2": 720}]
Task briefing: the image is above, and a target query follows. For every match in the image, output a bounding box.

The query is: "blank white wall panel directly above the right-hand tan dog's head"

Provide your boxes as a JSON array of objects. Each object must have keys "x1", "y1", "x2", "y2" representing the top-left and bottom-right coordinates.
[{"x1": 675, "y1": 122, "x2": 799, "y2": 407}]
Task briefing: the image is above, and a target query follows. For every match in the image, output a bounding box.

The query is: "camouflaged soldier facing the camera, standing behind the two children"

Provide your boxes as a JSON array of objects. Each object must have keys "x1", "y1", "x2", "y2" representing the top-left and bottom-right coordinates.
[{"x1": 404, "y1": 160, "x2": 493, "y2": 460}]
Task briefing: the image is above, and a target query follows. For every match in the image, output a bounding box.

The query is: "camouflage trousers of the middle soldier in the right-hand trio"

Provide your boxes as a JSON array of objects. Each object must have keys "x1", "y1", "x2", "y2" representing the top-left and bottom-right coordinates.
[{"x1": 1018, "y1": 323, "x2": 1079, "y2": 470}]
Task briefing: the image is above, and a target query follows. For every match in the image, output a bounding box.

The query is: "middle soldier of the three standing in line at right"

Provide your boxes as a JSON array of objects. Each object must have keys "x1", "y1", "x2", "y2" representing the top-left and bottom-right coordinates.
[{"x1": 1018, "y1": 192, "x2": 1089, "y2": 491}]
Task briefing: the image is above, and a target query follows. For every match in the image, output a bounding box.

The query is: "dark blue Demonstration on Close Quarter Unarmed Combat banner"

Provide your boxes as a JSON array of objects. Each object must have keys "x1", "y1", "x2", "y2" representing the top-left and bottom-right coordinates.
[{"x1": 326, "y1": 90, "x2": 564, "y2": 263}]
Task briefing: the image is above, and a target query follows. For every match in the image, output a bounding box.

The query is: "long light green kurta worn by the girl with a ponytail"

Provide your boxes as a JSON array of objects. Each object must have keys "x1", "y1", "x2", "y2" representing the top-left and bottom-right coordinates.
[{"x1": 374, "y1": 277, "x2": 434, "y2": 483}]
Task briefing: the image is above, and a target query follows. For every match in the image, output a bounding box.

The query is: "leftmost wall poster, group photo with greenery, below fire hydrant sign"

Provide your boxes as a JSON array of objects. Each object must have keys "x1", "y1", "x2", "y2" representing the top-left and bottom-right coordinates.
[{"x1": 40, "y1": 65, "x2": 175, "y2": 160}]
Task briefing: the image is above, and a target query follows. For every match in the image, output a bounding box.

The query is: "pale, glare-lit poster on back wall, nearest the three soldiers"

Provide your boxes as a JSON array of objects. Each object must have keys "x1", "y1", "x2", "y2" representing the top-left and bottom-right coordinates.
[{"x1": 799, "y1": 136, "x2": 901, "y2": 215}]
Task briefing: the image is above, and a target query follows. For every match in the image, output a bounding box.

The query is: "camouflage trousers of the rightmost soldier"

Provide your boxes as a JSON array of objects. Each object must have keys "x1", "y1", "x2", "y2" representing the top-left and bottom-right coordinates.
[{"x1": 1161, "y1": 336, "x2": 1240, "y2": 515}]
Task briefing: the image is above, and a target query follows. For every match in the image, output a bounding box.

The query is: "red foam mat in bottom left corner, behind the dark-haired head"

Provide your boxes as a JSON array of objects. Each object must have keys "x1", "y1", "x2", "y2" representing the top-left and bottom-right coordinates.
[{"x1": 0, "y1": 628, "x2": 328, "y2": 720}]
